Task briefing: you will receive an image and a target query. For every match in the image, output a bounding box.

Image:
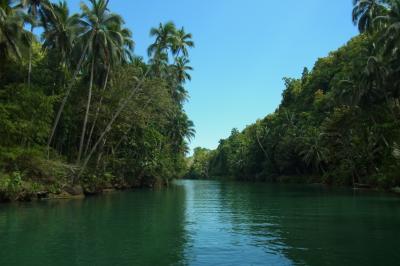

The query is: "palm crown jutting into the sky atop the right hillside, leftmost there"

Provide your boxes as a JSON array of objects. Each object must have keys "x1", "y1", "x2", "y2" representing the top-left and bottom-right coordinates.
[{"x1": 353, "y1": 0, "x2": 385, "y2": 32}]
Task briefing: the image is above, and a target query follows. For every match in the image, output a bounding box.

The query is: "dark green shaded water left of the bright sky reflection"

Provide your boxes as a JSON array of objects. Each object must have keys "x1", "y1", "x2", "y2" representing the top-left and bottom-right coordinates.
[{"x1": 0, "y1": 187, "x2": 186, "y2": 265}]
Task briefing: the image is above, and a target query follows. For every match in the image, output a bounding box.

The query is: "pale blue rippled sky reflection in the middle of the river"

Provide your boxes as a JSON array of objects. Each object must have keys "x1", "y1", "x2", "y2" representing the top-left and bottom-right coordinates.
[{"x1": 178, "y1": 181, "x2": 292, "y2": 265}]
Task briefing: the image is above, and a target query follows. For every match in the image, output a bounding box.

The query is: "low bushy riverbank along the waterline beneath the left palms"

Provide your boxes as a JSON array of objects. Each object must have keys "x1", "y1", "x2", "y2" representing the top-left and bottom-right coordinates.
[{"x1": 0, "y1": 157, "x2": 168, "y2": 203}]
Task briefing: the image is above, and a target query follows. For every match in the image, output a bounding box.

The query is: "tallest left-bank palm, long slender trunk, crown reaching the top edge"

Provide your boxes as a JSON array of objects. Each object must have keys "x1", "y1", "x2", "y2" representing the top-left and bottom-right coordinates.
[{"x1": 77, "y1": 0, "x2": 123, "y2": 164}]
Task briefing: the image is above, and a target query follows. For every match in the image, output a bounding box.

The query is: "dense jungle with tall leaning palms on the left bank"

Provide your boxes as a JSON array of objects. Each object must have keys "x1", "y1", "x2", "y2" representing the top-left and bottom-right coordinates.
[{"x1": 0, "y1": 0, "x2": 194, "y2": 201}]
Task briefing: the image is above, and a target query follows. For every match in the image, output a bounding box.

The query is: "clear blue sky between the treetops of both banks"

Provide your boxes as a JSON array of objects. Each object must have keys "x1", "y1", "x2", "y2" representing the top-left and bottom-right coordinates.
[{"x1": 68, "y1": 0, "x2": 357, "y2": 153}]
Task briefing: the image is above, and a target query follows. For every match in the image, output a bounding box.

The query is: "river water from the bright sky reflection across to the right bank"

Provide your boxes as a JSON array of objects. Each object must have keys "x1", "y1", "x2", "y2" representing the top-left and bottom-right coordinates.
[{"x1": 178, "y1": 181, "x2": 400, "y2": 265}]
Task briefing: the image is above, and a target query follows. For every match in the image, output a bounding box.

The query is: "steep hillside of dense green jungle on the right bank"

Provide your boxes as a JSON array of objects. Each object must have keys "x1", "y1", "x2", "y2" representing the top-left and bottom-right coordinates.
[{"x1": 188, "y1": 0, "x2": 400, "y2": 188}]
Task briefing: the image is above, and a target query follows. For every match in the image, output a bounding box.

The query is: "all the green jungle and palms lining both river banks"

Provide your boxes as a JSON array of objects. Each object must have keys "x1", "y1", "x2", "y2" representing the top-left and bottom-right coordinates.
[{"x1": 0, "y1": 0, "x2": 400, "y2": 201}]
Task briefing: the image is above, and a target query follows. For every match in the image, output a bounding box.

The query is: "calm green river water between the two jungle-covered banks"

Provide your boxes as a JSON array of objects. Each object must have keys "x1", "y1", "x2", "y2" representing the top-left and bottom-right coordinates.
[{"x1": 0, "y1": 180, "x2": 400, "y2": 266}]
